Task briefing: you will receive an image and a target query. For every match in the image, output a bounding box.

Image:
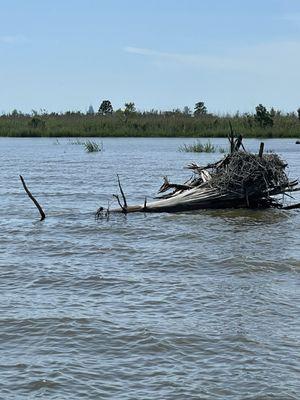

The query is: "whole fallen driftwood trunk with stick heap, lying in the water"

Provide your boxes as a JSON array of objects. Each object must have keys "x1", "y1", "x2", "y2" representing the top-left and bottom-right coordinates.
[{"x1": 96, "y1": 135, "x2": 300, "y2": 217}]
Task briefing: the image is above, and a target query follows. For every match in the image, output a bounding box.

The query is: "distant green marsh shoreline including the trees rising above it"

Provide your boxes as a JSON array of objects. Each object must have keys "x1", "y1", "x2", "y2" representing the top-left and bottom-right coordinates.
[{"x1": 0, "y1": 99, "x2": 300, "y2": 137}]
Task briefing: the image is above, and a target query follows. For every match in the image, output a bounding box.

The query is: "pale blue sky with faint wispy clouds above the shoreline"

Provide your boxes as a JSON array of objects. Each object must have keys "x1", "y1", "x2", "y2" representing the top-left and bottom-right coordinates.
[{"x1": 0, "y1": 0, "x2": 300, "y2": 114}]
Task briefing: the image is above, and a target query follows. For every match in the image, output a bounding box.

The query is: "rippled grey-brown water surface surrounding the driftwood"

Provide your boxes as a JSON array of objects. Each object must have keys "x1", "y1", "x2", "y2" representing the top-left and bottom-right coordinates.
[{"x1": 0, "y1": 138, "x2": 300, "y2": 400}]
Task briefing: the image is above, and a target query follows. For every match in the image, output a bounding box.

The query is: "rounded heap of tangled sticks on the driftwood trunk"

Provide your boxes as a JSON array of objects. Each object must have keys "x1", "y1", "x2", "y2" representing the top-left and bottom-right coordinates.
[{"x1": 182, "y1": 151, "x2": 297, "y2": 207}]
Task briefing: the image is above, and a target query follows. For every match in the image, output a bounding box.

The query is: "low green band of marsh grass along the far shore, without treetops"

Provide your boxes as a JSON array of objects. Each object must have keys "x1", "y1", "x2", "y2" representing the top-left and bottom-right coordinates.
[{"x1": 0, "y1": 113, "x2": 300, "y2": 138}]
